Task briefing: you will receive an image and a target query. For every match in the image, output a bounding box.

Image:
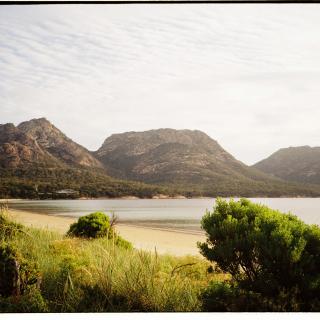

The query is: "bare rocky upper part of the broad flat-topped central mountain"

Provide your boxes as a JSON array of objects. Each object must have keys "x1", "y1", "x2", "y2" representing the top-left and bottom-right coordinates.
[{"x1": 96, "y1": 128, "x2": 249, "y2": 183}]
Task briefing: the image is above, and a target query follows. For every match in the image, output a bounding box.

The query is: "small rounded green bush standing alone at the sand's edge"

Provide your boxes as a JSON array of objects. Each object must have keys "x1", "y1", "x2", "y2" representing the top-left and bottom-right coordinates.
[{"x1": 67, "y1": 212, "x2": 113, "y2": 238}]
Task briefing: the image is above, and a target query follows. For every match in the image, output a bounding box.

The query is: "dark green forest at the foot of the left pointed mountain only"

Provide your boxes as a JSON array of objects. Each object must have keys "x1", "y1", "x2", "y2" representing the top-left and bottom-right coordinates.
[{"x1": 0, "y1": 167, "x2": 174, "y2": 199}]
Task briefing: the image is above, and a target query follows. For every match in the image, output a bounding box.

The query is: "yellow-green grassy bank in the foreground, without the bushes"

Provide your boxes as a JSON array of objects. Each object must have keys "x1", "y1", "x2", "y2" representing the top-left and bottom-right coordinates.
[{"x1": 0, "y1": 209, "x2": 225, "y2": 312}]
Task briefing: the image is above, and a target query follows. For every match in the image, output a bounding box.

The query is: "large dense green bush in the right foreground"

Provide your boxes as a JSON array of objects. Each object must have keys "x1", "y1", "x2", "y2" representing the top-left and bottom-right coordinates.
[{"x1": 198, "y1": 199, "x2": 320, "y2": 311}]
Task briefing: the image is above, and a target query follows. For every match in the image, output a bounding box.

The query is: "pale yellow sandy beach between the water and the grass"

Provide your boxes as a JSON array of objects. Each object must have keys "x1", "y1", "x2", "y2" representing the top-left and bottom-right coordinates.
[{"x1": 9, "y1": 209, "x2": 205, "y2": 256}]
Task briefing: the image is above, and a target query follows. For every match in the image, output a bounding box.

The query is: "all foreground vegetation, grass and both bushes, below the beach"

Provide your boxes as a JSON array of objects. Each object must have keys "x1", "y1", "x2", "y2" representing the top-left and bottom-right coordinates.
[{"x1": 0, "y1": 199, "x2": 320, "y2": 312}]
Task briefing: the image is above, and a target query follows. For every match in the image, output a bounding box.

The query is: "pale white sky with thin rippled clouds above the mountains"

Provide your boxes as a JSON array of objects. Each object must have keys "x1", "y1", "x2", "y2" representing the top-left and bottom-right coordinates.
[{"x1": 0, "y1": 4, "x2": 320, "y2": 165}]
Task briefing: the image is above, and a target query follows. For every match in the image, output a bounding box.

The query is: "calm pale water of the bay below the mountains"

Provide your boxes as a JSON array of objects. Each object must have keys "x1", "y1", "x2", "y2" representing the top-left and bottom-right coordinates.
[{"x1": 10, "y1": 198, "x2": 320, "y2": 232}]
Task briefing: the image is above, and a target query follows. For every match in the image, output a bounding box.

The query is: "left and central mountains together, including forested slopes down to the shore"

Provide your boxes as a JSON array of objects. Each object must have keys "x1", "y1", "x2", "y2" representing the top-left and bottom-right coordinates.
[{"x1": 0, "y1": 118, "x2": 320, "y2": 197}]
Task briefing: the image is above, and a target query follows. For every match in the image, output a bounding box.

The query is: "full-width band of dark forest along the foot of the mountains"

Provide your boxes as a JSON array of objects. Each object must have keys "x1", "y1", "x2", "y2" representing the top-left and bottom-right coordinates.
[{"x1": 0, "y1": 166, "x2": 320, "y2": 199}]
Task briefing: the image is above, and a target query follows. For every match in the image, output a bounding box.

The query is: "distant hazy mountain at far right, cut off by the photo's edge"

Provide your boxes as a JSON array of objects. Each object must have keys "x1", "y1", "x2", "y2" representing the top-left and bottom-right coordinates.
[{"x1": 253, "y1": 146, "x2": 320, "y2": 184}]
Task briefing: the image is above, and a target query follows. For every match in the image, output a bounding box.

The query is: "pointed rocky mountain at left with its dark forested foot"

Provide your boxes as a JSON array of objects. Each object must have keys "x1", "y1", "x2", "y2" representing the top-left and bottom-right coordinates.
[{"x1": 0, "y1": 118, "x2": 168, "y2": 198}]
